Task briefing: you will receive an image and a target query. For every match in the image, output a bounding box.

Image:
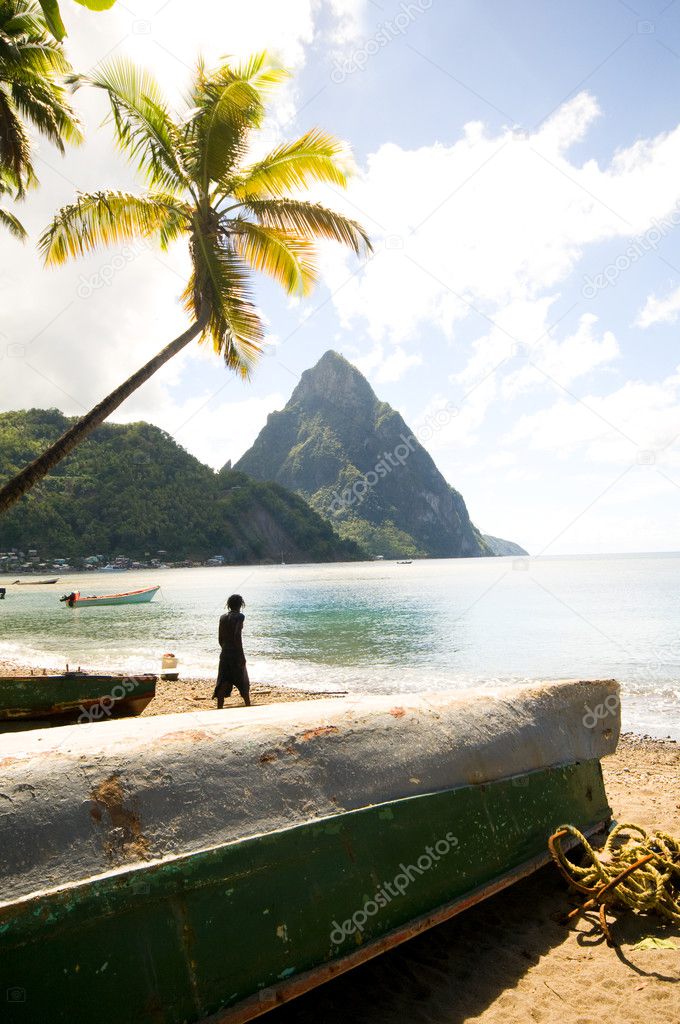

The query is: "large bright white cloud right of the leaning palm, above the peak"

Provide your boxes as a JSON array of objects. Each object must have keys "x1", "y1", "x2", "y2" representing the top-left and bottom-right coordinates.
[{"x1": 327, "y1": 93, "x2": 680, "y2": 345}]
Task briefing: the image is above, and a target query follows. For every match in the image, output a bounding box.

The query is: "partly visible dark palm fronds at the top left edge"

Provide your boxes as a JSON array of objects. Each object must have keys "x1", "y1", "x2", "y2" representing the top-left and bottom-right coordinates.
[{"x1": 0, "y1": 0, "x2": 82, "y2": 239}]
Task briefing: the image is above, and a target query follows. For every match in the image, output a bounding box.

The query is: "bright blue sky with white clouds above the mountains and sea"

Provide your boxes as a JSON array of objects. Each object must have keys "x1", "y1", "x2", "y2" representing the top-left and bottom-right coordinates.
[{"x1": 0, "y1": 0, "x2": 680, "y2": 555}]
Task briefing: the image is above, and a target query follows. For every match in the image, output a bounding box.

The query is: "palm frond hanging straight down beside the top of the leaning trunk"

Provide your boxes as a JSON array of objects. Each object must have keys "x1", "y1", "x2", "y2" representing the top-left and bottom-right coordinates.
[{"x1": 183, "y1": 233, "x2": 264, "y2": 377}]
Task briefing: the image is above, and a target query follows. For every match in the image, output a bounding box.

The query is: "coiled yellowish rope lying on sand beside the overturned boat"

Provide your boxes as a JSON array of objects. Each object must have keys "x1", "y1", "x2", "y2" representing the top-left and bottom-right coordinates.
[{"x1": 548, "y1": 823, "x2": 680, "y2": 945}]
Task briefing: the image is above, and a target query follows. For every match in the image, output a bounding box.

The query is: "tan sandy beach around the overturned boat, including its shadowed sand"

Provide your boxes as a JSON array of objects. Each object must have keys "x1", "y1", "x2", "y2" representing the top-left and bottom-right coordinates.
[{"x1": 0, "y1": 664, "x2": 680, "y2": 1024}]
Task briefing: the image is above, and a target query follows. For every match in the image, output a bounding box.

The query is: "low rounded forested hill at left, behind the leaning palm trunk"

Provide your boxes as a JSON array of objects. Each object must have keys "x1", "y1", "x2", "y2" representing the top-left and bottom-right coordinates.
[{"x1": 0, "y1": 409, "x2": 363, "y2": 563}]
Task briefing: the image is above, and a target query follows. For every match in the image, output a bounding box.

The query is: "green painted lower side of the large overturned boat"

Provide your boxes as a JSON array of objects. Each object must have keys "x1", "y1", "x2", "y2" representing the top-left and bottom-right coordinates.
[{"x1": 0, "y1": 761, "x2": 610, "y2": 1024}]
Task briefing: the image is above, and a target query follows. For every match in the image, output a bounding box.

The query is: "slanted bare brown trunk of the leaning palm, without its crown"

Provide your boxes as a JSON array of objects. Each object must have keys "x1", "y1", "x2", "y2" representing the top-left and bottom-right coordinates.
[{"x1": 0, "y1": 312, "x2": 208, "y2": 514}]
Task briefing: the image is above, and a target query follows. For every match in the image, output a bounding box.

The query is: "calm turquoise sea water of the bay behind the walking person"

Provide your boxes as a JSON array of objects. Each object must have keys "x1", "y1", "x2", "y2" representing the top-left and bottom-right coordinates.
[{"x1": 0, "y1": 554, "x2": 680, "y2": 739}]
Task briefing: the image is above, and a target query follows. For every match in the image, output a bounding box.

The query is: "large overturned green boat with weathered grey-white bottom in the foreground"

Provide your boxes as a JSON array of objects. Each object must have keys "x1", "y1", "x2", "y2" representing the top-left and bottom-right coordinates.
[{"x1": 0, "y1": 682, "x2": 619, "y2": 1024}]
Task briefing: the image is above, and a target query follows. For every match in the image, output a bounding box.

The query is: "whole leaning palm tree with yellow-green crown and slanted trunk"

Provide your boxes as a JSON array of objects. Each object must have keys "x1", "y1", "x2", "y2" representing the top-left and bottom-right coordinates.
[{"x1": 0, "y1": 53, "x2": 371, "y2": 512}]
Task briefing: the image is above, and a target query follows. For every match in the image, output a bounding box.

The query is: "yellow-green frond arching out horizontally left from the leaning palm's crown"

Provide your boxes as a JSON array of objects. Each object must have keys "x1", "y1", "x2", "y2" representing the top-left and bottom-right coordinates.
[{"x1": 38, "y1": 191, "x2": 190, "y2": 265}]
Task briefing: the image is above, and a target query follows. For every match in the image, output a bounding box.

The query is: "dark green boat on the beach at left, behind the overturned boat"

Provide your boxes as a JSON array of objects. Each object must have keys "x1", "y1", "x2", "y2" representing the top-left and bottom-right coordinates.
[{"x1": 0, "y1": 672, "x2": 157, "y2": 732}]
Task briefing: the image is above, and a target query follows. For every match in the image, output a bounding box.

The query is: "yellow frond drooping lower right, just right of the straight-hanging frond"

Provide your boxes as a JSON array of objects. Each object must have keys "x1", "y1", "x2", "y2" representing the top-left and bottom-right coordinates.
[{"x1": 228, "y1": 219, "x2": 316, "y2": 295}]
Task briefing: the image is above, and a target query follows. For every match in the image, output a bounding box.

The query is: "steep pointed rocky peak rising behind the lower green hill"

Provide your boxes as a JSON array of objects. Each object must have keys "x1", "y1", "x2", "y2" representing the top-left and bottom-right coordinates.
[{"x1": 237, "y1": 351, "x2": 492, "y2": 558}]
